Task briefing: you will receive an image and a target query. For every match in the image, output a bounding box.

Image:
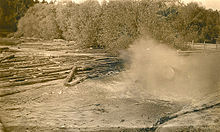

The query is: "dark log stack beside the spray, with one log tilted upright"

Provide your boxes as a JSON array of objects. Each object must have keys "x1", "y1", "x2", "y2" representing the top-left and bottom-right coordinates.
[{"x1": 64, "y1": 57, "x2": 123, "y2": 86}]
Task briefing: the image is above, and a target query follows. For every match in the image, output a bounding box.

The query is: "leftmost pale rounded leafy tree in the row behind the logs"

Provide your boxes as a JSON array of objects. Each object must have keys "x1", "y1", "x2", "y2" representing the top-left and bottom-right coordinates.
[{"x1": 15, "y1": 3, "x2": 60, "y2": 39}]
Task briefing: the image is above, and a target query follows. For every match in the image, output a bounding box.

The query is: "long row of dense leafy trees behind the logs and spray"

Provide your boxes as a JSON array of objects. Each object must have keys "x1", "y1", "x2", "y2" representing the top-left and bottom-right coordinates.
[{"x1": 16, "y1": 0, "x2": 220, "y2": 51}]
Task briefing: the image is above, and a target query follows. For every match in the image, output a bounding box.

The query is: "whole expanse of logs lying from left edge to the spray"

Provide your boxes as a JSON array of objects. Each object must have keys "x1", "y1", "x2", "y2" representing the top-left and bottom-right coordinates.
[{"x1": 0, "y1": 41, "x2": 123, "y2": 97}]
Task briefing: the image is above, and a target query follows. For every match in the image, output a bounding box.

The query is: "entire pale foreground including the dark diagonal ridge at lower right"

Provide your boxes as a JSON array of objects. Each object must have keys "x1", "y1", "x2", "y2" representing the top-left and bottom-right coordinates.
[{"x1": 0, "y1": 75, "x2": 220, "y2": 132}]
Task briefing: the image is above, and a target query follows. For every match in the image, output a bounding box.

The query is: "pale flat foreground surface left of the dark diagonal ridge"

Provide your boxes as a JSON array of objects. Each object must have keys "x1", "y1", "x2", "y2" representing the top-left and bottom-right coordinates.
[{"x1": 1, "y1": 78, "x2": 182, "y2": 131}]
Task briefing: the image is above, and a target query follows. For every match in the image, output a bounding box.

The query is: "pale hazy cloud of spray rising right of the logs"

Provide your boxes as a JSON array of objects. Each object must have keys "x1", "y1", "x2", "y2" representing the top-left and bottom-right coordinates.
[{"x1": 121, "y1": 39, "x2": 220, "y2": 100}]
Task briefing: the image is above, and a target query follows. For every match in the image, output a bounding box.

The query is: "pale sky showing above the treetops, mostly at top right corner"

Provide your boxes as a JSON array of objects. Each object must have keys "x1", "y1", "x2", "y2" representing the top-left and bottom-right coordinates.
[{"x1": 40, "y1": 0, "x2": 220, "y2": 10}]
